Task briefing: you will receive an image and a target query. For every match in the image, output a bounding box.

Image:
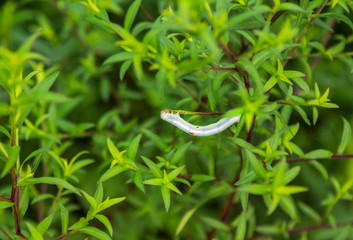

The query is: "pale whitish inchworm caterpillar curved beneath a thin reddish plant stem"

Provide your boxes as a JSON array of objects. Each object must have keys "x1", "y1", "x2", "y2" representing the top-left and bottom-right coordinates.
[{"x1": 161, "y1": 110, "x2": 240, "y2": 137}]
